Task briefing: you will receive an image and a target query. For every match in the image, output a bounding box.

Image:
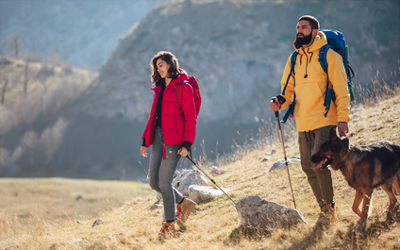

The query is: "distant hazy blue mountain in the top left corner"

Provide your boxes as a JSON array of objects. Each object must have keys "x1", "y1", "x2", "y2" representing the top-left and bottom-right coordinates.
[{"x1": 0, "y1": 0, "x2": 166, "y2": 70}]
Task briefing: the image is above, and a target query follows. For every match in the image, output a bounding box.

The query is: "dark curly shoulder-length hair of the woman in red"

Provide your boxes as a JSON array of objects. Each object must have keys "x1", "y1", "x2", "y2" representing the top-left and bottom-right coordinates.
[{"x1": 150, "y1": 51, "x2": 179, "y2": 85}]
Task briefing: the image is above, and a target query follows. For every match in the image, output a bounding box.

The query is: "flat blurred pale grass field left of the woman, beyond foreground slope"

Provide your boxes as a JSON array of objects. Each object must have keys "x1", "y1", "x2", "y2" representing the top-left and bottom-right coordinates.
[{"x1": 0, "y1": 178, "x2": 150, "y2": 249}]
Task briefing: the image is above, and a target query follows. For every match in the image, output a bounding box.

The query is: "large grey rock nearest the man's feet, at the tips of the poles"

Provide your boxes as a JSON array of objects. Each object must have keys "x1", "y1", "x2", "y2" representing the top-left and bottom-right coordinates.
[{"x1": 236, "y1": 196, "x2": 307, "y2": 230}]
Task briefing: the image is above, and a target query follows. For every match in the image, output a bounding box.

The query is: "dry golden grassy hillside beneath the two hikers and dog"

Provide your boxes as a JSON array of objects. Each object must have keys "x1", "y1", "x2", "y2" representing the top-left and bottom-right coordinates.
[{"x1": 0, "y1": 88, "x2": 400, "y2": 249}]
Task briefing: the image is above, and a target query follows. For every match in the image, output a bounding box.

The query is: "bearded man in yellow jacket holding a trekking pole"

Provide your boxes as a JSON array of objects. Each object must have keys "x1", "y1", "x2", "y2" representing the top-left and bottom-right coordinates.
[{"x1": 270, "y1": 15, "x2": 350, "y2": 227}]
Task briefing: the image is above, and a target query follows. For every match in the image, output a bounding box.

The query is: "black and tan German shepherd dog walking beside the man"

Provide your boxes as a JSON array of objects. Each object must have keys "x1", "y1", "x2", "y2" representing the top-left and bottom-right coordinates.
[{"x1": 311, "y1": 129, "x2": 400, "y2": 224}]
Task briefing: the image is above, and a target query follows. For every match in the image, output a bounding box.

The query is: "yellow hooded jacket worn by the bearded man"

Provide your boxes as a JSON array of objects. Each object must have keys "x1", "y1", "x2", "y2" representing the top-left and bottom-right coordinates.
[{"x1": 280, "y1": 31, "x2": 350, "y2": 132}]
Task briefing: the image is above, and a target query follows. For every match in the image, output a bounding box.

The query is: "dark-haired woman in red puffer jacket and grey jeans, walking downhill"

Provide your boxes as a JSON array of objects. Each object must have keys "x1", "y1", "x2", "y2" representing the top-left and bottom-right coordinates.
[{"x1": 140, "y1": 51, "x2": 197, "y2": 239}]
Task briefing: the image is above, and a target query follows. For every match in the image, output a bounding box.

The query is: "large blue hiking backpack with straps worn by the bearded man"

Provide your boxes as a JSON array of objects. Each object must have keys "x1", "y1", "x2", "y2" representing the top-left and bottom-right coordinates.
[{"x1": 281, "y1": 29, "x2": 355, "y2": 123}]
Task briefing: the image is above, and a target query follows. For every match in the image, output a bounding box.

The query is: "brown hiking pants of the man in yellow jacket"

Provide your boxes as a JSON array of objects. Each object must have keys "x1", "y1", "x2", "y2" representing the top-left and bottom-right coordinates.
[{"x1": 299, "y1": 126, "x2": 336, "y2": 207}]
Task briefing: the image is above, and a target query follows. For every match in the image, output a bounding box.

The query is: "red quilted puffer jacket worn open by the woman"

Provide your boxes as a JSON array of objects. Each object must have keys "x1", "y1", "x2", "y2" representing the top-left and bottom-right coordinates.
[{"x1": 142, "y1": 69, "x2": 197, "y2": 147}]
